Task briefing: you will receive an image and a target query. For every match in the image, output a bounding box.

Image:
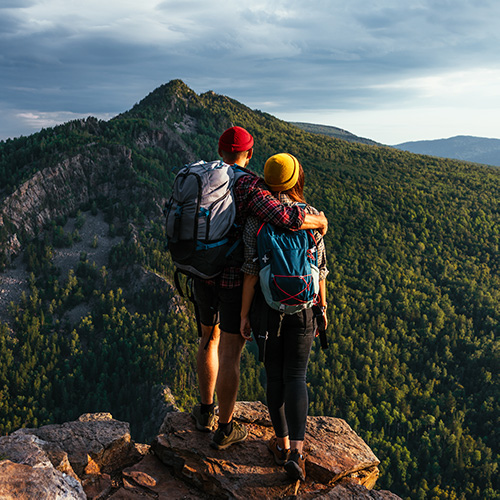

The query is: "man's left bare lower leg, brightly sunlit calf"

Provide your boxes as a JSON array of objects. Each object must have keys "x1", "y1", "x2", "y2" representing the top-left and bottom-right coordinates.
[{"x1": 196, "y1": 324, "x2": 220, "y2": 405}]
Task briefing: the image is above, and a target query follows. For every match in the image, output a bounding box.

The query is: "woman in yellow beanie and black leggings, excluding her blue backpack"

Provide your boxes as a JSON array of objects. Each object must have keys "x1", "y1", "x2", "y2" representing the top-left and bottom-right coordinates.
[{"x1": 240, "y1": 153, "x2": 328, "y2": 481}]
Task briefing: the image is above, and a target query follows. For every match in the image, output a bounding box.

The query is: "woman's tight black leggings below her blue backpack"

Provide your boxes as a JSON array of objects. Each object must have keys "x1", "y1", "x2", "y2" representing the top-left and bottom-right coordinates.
[{"x1": 264, "y1": 309, "x2": 315, "y2": 441}]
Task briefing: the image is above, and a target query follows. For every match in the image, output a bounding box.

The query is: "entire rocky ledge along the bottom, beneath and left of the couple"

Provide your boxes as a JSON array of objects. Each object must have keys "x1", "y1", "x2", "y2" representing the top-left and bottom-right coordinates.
[{"x1": 0, "y1": 402, "x2": 399, "y2": 500}]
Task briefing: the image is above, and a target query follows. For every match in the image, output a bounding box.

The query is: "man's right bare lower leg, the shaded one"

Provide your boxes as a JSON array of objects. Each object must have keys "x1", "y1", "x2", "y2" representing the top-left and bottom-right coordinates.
[{"x1": 216, "y1": 331, "x2": 245, "y2": 424}]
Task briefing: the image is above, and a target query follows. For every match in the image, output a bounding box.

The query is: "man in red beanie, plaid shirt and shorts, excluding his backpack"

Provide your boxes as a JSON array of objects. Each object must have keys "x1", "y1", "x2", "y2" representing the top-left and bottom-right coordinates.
[{"x1": 192, "y1": 127, "x2": 328, "y2": 449}]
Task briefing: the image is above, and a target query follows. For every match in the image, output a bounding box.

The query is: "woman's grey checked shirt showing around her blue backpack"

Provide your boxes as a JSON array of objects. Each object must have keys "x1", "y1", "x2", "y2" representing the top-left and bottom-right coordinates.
[{"x1": 241, "y1": 193, "x2": 328, "y2": 281}]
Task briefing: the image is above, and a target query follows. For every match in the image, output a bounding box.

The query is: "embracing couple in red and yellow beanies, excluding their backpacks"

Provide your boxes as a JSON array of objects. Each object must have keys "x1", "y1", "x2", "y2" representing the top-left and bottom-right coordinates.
[{"x1": 188, "y1": 127, "x2": 328, "y2": 480}]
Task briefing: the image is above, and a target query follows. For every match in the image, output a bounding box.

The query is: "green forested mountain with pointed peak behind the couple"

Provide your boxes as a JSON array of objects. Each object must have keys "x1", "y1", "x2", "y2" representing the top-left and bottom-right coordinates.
[{"x1": 0, "y1": 80, "x2": 500, "y2": 500}]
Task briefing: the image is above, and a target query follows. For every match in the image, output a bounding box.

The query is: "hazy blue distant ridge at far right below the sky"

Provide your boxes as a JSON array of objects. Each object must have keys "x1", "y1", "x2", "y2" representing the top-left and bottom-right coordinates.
[{"x1": 393, "y1": 135, "x2": 500, "y2": 167}]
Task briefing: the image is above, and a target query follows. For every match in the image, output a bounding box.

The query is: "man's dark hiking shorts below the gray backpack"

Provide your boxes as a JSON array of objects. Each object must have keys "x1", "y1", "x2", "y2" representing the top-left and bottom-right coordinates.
[{"x1": 193, "y1": 279, "x2": 242, "y2": 335}]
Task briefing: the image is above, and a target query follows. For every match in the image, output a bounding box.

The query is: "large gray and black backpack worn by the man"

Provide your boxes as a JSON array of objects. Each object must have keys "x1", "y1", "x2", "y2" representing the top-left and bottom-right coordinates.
[{"x1": 164, "y1": 160, "x2": 246, "y2": 279}]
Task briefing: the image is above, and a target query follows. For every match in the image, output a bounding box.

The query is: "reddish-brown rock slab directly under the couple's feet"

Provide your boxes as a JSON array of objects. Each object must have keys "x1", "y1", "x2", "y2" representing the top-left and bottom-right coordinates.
[{"x1": 152, "y1": 403, "x2": 398, "y2": 499}]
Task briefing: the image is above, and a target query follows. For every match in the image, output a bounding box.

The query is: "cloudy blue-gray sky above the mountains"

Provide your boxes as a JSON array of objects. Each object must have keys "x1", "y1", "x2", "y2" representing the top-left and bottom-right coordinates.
[{"x1": 0, "y1": 0, "x2": 500, "y2": 145}]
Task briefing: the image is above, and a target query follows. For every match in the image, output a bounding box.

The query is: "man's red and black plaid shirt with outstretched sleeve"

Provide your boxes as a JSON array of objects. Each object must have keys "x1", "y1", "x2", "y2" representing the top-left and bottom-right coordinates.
[{"x1": 208, "y1": 169, "x2": 305, "y2": 288}]
